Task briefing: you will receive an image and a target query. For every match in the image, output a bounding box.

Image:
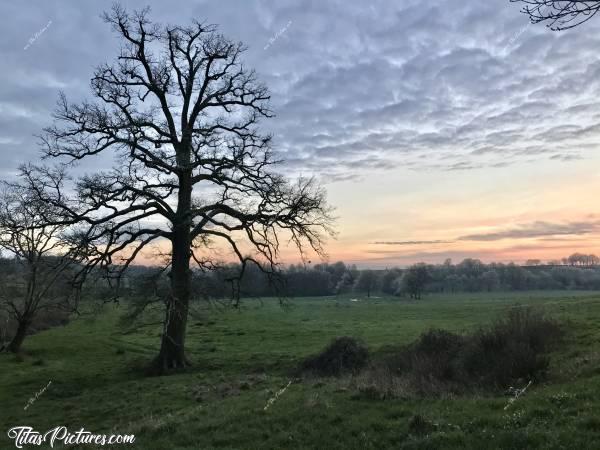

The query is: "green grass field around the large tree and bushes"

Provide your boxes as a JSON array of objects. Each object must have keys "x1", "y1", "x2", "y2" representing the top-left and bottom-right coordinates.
[{"x1": 0, "y1": 292, "x2": 600, "y2": 450}]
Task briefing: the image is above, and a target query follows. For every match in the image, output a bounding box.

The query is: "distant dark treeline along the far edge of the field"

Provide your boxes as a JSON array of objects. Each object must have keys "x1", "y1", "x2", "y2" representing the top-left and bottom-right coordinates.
[{"x1": 120, "y1": 253, "x2": 600, "y2": 298}]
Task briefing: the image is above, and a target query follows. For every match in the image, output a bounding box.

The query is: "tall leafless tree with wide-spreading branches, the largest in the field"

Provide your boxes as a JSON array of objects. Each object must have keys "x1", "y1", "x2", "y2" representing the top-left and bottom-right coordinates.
[{"x1": 23, "y1": 6, "x2": 332, "y2": 373}]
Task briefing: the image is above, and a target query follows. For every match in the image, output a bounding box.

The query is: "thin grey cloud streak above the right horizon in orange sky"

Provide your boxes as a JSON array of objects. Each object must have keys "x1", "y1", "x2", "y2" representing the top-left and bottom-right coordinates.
[{"x1": 458, "y1": 220, "x2": 600, "y2": 241}]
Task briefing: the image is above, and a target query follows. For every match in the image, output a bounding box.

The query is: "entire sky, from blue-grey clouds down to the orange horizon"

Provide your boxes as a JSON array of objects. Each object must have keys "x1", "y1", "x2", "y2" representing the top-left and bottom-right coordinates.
[{"x1": 0, "y1": 0, "x2": 600, "y2": 268}]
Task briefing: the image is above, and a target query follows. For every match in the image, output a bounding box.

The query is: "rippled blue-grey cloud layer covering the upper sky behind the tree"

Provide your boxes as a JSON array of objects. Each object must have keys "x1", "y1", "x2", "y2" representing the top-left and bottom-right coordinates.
[{"x1": 0, "y1": 0, "x2": 600, "y2": 181}]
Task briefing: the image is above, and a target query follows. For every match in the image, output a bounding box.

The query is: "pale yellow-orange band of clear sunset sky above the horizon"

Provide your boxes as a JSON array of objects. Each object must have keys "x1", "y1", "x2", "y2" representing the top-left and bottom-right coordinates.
[{"x1": 138, "y1": 158, "x2": 600, "y2": 268}]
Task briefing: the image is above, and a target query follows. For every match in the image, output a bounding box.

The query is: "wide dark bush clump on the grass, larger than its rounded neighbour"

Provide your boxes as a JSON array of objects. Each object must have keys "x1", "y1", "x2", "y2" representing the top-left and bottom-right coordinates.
[{"x1": 356, "y1": 308, "x2": 562, "y2": 398}]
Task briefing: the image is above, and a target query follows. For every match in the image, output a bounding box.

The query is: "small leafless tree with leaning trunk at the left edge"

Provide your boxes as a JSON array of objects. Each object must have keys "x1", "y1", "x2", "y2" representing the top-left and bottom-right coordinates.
[{"x1": 0, "y1": 182, "x2": 81, "y2": 353}]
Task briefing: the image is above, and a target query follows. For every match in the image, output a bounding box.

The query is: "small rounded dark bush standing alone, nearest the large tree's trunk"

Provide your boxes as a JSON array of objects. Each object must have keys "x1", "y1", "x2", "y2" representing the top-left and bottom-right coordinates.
[{"x1": 300, "y1": 337, "x2": 369, "y2": 377}]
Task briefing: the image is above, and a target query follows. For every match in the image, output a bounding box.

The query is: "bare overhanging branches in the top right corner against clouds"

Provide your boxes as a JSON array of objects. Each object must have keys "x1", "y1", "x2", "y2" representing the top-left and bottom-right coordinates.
[{"x1": 510, "y1": 0, "x2": 600, "y2": 31}]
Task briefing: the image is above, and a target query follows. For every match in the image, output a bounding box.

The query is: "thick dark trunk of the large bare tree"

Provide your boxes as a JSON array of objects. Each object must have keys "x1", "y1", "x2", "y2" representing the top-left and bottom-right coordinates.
[{"x1": 151, "y1": 163, "x2": 192, "y2": 375}]
